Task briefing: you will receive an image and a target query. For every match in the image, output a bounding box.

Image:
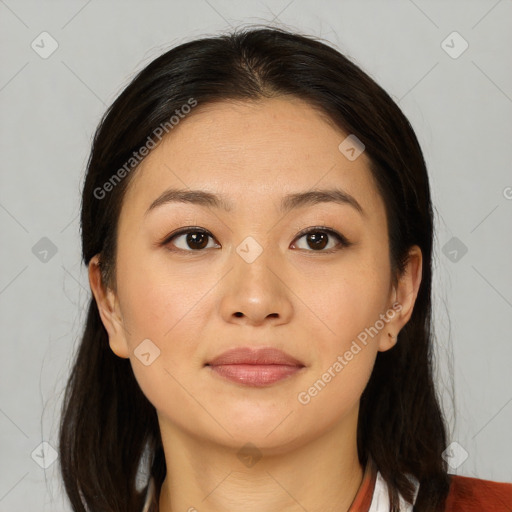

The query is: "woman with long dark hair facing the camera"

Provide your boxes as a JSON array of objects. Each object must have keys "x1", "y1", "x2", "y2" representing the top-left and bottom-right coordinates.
[{"x1": 60, "y1": 28, "x2": 512, "y2": 512}]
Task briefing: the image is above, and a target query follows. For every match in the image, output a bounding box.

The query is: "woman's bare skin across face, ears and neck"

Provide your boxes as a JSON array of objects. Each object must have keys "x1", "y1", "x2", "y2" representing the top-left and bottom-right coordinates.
[{"x1": 89, "y1": 97, "x2": 421, "y2": 512}]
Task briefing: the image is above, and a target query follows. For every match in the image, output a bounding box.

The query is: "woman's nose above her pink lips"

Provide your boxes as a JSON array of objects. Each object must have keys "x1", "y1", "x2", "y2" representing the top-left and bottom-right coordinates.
[{"x1": 220, "y1": 242, "x2": 293, "y2": 325}]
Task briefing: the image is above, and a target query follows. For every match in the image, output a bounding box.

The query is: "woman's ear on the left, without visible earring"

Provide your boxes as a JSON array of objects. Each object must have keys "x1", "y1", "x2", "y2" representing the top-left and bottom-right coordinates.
[{"x1": 89, "y1": 254, "x2": 130, "y2": 358}]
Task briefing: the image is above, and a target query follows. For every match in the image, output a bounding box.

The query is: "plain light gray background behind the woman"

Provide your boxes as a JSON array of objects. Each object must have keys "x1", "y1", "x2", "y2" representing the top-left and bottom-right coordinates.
[{"x1": 0, "y1": 0, "x2": 512, "y2": 512}]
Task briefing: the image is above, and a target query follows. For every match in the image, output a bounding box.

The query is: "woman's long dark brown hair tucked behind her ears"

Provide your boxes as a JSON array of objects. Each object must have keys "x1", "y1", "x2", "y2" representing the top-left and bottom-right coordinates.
[{"x1": 59, "y1": 27, "x2": 449, "y2": 512}]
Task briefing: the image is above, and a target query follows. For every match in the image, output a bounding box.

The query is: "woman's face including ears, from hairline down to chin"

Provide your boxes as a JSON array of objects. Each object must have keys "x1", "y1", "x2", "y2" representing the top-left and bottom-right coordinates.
[{"x1": 90, "y1": 98, "x2": 421, "y2": 450}]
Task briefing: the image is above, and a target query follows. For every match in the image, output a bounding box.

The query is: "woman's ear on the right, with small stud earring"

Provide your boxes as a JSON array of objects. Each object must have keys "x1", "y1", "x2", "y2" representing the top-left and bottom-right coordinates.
[{"x1": 378, "y1": 245, "x2": 423, "y2": 352}]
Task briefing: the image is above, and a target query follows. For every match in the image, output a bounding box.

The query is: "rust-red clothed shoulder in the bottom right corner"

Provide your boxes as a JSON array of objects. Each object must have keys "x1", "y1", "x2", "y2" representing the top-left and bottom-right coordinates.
[{"x1": 445, "y1": 475, "x2": 512, "y2": 512}]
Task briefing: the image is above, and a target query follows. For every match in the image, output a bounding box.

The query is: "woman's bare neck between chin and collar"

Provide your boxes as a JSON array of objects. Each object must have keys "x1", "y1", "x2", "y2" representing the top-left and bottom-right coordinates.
[{"x1": 159, "y1": 404, "x2": 363, "y2": 512}]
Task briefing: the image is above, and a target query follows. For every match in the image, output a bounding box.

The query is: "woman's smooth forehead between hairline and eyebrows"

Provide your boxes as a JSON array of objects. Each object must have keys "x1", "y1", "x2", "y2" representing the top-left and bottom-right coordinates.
[{"x1": 123, "y1": 97, "x2": 383, "y2": 220}]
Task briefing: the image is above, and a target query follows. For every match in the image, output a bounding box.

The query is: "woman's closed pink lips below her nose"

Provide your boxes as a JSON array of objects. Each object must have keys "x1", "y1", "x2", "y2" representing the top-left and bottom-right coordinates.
[{"x1": 205, "y1": 347, "x2": 305, "y2": 387}]
